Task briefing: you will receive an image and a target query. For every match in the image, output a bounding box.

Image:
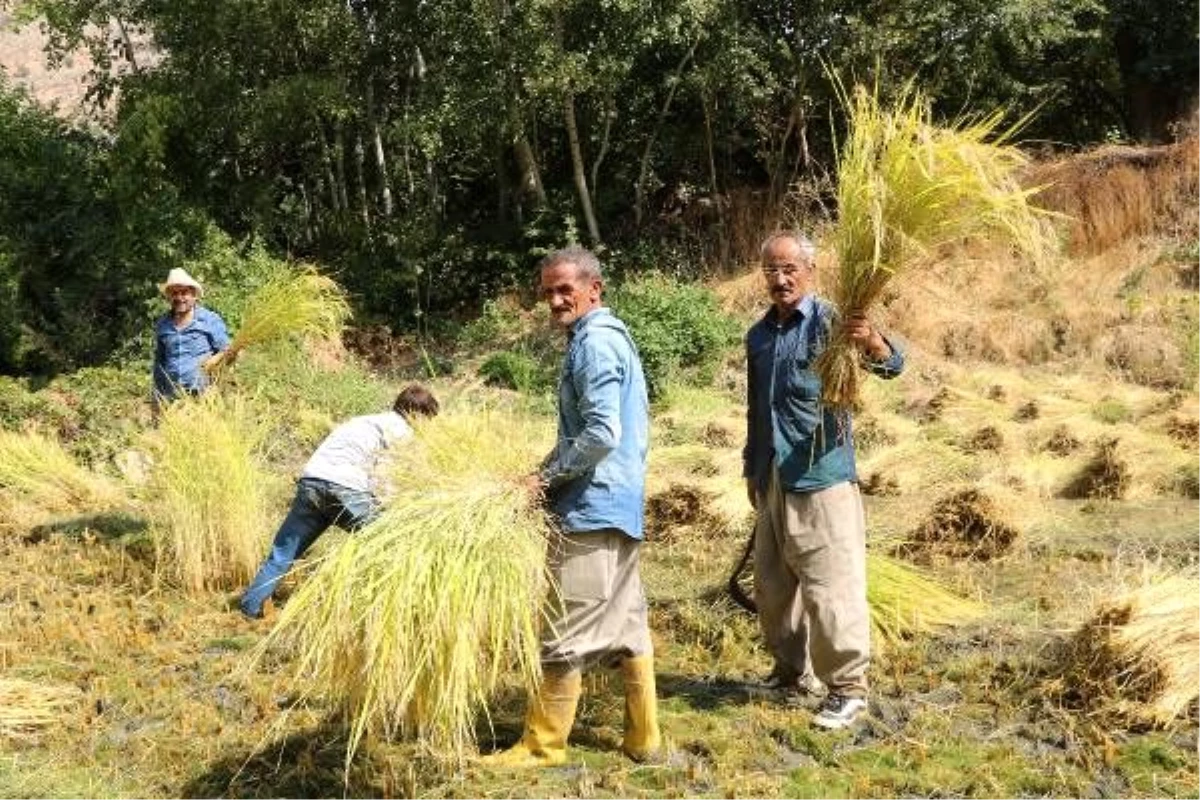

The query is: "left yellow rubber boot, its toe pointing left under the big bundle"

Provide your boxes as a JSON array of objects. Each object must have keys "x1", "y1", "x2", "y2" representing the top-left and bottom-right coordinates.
[{"x1": 482, "y1": 669, "x2": 583, "y2": 766}]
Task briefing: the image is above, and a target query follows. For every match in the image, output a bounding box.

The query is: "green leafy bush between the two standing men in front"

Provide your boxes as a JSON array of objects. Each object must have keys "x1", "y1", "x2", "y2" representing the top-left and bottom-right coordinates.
[{"x1": 608, "y1": 273, "x2": 740, "y2": 398}]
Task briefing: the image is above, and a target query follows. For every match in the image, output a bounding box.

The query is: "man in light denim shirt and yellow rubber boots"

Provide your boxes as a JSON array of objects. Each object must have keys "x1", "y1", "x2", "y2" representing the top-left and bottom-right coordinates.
[{"x1": 484, "y1": 247, "x2": 660, "y2": 766}]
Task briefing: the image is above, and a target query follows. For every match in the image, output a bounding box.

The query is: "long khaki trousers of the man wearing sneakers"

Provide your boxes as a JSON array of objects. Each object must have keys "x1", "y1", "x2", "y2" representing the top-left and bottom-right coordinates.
[{"x1": 754, "y1": 470, "x2": 871, "y2": 697}]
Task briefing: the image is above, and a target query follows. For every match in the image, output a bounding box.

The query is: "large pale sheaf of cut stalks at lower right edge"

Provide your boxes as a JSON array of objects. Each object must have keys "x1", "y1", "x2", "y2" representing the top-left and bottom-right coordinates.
[{"x1": 1057, "y1": 575, "x2": 1200, "y2": 724}]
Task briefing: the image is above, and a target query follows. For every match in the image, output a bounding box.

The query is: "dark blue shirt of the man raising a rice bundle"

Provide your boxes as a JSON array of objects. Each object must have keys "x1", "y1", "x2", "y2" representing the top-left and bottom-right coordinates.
[{"x1": 742, "y1": 294, "x2": 904, "y2": 492}]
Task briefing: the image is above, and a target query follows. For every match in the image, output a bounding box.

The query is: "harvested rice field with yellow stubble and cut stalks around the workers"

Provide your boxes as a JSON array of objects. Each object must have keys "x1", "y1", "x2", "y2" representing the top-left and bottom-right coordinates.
[{"x1": 0, "y1": 153, "x2": 1200, "y2": 799}]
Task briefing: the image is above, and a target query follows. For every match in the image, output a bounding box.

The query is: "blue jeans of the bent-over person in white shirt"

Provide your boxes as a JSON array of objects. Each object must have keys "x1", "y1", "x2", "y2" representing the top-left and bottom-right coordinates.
[{"x1": 241, "y1": 477, "x2": 379, "y2": 616}]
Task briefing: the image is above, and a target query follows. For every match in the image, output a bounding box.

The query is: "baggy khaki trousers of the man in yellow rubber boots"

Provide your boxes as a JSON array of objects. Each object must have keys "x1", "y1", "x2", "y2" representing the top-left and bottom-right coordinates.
[{"x1": 541, "y1": 529, "x2": 652, "y2": 670}]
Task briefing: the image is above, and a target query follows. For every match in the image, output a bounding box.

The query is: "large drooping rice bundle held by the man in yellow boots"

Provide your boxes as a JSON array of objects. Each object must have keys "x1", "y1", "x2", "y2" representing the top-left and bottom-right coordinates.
[{"x1": 258, "y1": 411, "x2": 548, "y2": 763}]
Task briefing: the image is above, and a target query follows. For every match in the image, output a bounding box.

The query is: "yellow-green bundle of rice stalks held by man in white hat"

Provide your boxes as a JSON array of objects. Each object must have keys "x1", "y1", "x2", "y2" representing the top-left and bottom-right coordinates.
[{"x1": 229, "y1": 267, "x2": 350, "y2": 353}]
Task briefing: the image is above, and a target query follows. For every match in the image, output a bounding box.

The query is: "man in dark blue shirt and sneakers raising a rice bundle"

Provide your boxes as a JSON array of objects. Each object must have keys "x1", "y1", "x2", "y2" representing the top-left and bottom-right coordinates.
[{"x1": 743, "y1": 234, "x2": 904, "y2": 729}]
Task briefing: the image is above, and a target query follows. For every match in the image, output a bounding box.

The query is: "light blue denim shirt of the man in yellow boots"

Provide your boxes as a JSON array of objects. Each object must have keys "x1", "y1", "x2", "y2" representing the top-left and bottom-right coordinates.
[{"x1": 541, "y1": 308, "x2": 650, "y2": 539}]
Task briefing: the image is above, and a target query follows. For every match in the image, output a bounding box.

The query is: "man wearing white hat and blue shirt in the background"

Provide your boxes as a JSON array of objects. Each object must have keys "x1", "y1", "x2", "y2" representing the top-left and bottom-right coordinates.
[{"x1": 154, "y1": 266, "x2": 233, "y2": 403}]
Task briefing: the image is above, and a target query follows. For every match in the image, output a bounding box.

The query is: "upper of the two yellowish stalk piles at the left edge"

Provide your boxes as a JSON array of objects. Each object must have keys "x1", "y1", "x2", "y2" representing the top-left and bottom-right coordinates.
[{"x1": 0, "y1": 431, "x2": 120, "y2": 512}]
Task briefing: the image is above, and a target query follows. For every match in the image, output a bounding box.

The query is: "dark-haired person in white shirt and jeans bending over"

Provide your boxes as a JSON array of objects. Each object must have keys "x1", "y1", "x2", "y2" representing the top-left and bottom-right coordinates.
[{"x1": 240, "y1": 384, "x2": 438, "y2": 619}]
